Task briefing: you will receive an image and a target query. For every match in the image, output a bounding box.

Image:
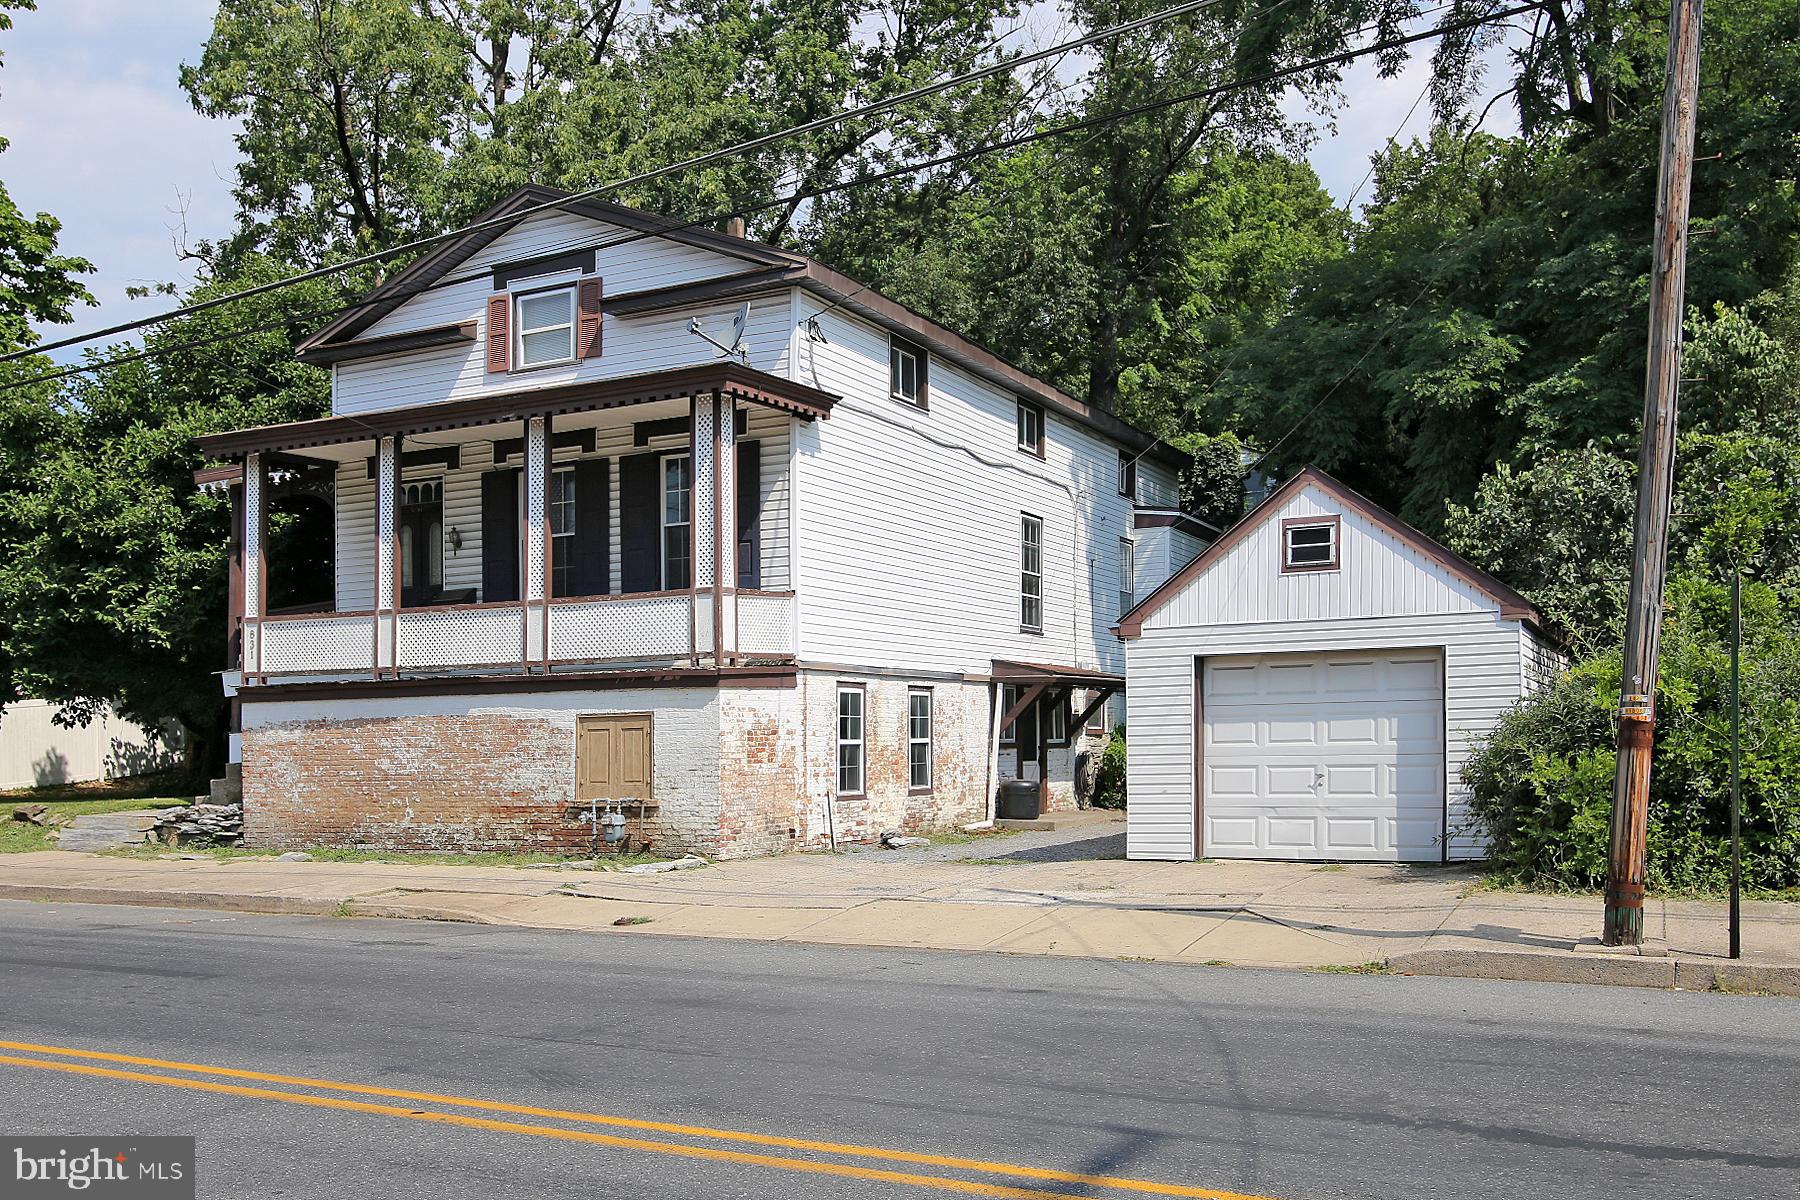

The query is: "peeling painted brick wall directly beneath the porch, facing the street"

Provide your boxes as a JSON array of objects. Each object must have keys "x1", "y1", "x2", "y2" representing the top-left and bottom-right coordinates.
[{"x1": 243, "y1": 689, "x2": 720, "y2": 855}]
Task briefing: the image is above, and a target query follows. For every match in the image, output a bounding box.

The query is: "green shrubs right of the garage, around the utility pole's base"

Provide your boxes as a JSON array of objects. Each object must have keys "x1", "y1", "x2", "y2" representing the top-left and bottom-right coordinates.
[{"x1": 1463, "y1": 578, "x2": 1800, "y2": 891}]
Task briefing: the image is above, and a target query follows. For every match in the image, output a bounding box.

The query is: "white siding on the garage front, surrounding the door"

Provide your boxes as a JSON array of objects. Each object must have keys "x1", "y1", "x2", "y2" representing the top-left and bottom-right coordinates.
[{"x1": 1125, "y1": 486, "x2": 1526, "y2": 860}]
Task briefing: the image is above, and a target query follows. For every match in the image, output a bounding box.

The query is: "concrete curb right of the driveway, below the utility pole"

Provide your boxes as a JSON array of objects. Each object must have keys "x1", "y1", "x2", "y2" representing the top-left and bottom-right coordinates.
[{"x1": 1388, "y1": 950, "x2": 1800, "y2": 997}]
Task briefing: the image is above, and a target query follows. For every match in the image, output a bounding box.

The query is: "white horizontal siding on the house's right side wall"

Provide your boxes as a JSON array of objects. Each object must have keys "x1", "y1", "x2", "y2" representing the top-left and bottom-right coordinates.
[{"x1": 796, "y1": 295, "x2": 1175, "y2": 673}]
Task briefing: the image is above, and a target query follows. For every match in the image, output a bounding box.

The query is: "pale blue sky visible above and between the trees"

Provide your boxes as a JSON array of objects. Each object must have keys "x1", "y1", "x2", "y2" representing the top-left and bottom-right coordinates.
[{"x1": 0, "y1": 0, "x2": 1512, "y2": 354}]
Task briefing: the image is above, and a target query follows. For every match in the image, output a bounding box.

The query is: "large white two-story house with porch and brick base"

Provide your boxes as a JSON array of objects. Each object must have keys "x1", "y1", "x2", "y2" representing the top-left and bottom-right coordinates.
[{"x1": 198, "y1": 187, "x2": 1204, "y2": 855}]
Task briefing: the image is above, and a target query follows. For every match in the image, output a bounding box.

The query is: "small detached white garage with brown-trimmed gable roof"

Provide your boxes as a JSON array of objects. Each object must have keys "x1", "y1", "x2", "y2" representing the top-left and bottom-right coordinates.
[{"x1": 1120, "y1": 470, "x2": 1561, "y2": 862}]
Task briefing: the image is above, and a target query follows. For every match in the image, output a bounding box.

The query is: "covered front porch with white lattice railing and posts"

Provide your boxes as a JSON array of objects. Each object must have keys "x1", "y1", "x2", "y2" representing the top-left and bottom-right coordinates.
[{"x1": 198, "y1": 362, "x2": 835, "y2": 687}]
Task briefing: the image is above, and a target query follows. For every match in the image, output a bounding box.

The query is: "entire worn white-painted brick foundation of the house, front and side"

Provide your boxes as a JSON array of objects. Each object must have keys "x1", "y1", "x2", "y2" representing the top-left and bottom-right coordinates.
[{"x1": 243, "y1": 671, "x2": 1098, "y2": 858}]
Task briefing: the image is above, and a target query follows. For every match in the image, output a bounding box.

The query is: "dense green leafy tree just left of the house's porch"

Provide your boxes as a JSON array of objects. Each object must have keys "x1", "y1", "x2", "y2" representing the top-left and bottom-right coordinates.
[{"x1": 0, "y1": 257, "x2": 329, "y2": 770}]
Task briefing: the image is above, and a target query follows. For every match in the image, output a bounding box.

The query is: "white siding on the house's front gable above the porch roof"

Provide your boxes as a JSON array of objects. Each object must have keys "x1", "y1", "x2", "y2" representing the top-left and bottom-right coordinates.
[{"x1": 331, "y1": 212, "x2": 790, "y2": 416}]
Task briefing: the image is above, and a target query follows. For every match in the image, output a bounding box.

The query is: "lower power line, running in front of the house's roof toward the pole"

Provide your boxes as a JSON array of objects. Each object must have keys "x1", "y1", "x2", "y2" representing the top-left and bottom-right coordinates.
[{"x1": 0, "y1": 0, "x2": 1548, "y2": 395}]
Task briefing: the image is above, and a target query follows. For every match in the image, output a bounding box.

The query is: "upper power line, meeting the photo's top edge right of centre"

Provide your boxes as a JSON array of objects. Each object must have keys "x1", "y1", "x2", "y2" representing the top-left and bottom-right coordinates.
[{"x1": 0, "y1": 0, "x2": 1252, "y2": 363}]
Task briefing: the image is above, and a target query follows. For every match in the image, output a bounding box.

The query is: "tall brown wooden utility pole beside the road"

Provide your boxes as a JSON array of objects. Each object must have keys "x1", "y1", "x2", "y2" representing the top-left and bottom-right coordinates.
[{"x1": 1600, "y1": 0, "x2": 1701, "y2": 946}]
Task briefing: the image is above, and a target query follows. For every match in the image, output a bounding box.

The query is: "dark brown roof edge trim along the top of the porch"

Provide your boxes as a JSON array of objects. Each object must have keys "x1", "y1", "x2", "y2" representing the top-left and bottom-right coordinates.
[{"x1": 194, "y1": 360, "x2": 839, "y2": 459}]
